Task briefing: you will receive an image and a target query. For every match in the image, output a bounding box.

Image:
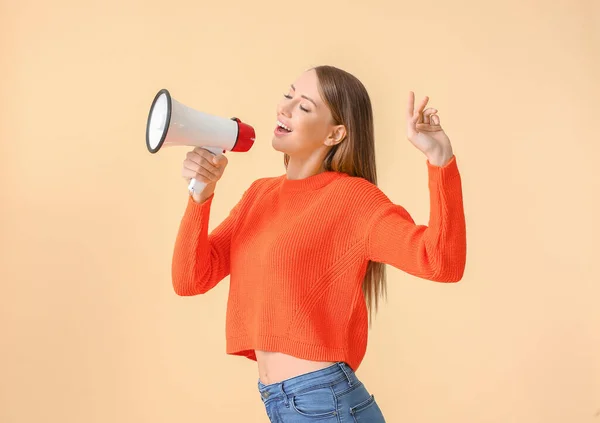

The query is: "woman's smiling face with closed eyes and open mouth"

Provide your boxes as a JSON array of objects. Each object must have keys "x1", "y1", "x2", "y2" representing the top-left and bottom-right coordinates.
[{"x1": 272, "y1": 69, "x2": 343, "y2": 158}]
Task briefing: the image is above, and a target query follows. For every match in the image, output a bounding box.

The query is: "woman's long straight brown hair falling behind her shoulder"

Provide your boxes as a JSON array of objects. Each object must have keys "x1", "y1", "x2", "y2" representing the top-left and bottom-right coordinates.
[{"x1": 284, "y1": 66, "x2": 386, "y2": 320}]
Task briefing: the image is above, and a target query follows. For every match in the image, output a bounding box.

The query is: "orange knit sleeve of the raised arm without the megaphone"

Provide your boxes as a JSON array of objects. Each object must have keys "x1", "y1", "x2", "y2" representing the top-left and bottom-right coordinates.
[{"x1": 366, "y1": 156, "x2": 466, "y2": 282}]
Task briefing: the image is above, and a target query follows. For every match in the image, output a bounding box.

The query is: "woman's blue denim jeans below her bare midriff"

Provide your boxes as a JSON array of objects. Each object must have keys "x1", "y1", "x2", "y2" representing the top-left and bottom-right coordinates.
[{"x1": 258, "y1": 362, "x2": 385, "y2": 423}]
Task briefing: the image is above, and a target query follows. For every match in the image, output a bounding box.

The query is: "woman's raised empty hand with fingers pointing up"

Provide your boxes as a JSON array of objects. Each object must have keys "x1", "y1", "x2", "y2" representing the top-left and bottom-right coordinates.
[{"x1": 407, "y1": 91, "x2": 454, "y2": 166}]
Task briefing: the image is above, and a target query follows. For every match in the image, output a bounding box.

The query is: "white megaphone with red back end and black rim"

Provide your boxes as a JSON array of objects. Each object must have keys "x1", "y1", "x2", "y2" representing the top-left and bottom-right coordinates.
[{"x1": 146, "y1": 88, "x2": 256, "y2": 192}]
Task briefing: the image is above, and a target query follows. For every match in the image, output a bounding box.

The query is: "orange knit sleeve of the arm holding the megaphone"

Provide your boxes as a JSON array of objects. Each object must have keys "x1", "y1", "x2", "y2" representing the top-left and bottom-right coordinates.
[{"x1": 172, "y1": 194, "x2": 242, "y2": 296}]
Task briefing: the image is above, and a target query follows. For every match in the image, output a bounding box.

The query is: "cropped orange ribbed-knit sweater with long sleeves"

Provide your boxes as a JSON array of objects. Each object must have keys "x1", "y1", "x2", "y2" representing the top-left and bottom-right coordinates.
[{"x1": 172, "y1": 157, "x2": 466, "y2": 370}]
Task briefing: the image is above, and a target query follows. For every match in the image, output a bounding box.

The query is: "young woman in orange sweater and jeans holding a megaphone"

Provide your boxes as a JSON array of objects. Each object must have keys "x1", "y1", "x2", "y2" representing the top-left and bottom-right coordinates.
[{"x1": 172, "y1": 66, "x2": 466, "y2": 423}]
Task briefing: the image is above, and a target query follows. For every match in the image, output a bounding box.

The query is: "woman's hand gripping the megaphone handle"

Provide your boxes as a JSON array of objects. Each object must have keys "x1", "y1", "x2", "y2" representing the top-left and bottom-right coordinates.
[{"x1": 181, "y1": 147, "x2": 229, "y2": 203}]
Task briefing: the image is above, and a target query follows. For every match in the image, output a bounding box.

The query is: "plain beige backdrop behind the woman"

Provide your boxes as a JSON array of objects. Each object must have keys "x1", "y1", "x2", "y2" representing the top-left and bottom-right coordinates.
[{"x1": 0, "y1": 0, "x2": 600, "y2": 423}]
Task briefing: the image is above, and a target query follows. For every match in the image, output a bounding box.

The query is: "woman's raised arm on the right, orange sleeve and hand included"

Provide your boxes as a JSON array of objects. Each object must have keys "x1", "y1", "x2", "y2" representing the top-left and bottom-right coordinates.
[{"x1": 366, "y1": 91, "x2": 467, "y2": 282}]
